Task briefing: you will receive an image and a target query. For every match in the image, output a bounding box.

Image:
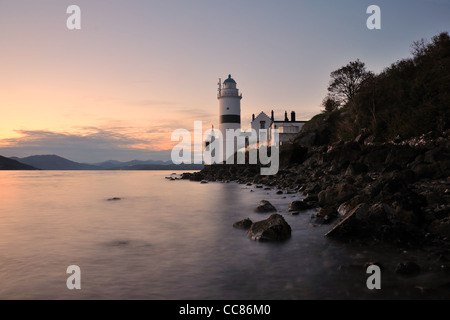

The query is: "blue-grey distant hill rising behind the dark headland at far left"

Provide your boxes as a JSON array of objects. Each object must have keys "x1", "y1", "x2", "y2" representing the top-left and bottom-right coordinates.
[{"x1": 11, "y1": 155, "x2": 102, "y2": 170}]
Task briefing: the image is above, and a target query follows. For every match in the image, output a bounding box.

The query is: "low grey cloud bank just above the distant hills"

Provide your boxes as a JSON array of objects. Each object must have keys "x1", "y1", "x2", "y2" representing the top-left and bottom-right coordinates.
[{"x1": 0, "y1": 127, "x2": 171, "y2": 163}]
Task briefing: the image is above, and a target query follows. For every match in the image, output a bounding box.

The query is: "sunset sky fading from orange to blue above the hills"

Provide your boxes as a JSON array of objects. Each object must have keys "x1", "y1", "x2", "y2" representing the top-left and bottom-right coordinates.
[{"x1": 0, "y1": 0, "x2": 450, "y2": 163}]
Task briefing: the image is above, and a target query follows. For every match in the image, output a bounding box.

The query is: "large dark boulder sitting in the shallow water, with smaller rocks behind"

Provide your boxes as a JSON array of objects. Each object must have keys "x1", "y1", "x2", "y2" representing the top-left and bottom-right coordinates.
[{"x1": 247, "y1": 213, "x2": 291, "y2": 241}]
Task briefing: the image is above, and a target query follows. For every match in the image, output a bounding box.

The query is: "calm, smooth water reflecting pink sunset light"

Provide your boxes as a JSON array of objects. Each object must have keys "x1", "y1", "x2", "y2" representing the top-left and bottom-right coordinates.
[{"x1": 0, "y1": 171, "x2": 450, "y2": 299}]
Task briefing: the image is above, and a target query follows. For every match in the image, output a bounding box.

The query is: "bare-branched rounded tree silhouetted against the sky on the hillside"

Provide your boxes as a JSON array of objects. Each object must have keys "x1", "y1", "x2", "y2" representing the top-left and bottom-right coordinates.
[{"x1": 328, "y1": 59, "x2": 374, "y2": 105}]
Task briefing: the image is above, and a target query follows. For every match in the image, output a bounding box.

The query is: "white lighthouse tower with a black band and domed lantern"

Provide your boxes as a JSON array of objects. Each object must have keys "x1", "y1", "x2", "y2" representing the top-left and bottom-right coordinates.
[{"x1": 217, "y1": 74, "x2": 242, "y2": 162}]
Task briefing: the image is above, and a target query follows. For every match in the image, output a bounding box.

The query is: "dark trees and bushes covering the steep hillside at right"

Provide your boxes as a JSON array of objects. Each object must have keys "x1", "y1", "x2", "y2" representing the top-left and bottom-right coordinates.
[{"x1": 310, "y1": 32, "x2": 450, "y2": 142}]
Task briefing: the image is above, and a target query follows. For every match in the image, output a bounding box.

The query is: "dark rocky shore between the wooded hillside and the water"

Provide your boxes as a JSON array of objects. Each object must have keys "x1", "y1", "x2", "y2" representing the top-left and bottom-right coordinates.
[{"x1": 182, "y1": 130, "x2": 450, "y2": 250}]
